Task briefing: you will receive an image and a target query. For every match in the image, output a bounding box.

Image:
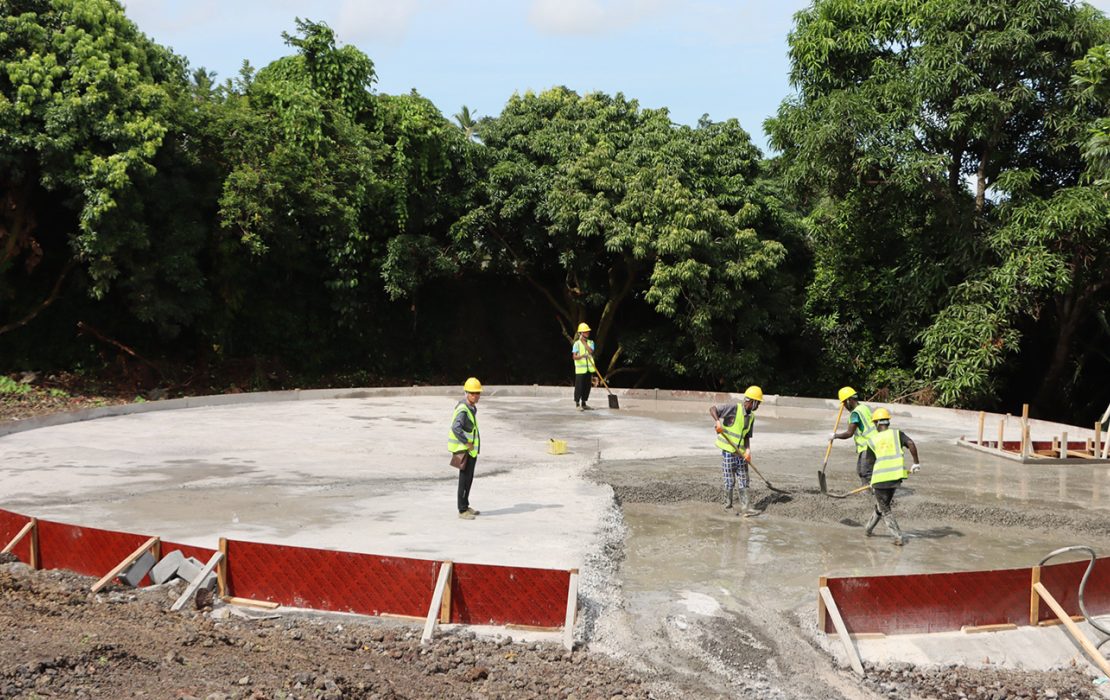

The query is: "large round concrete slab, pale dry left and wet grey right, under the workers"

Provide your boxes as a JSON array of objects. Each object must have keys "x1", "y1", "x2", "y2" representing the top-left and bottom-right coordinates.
[{"x1": 0, "y1": 387, "x2": 1110, "y2": 698}]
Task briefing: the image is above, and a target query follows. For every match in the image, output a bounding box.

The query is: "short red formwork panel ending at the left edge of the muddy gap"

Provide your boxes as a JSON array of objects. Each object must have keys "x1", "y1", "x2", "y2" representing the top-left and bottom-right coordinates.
[{"x1": 451, "y1": 564, "x2": 571, "y2": 627}]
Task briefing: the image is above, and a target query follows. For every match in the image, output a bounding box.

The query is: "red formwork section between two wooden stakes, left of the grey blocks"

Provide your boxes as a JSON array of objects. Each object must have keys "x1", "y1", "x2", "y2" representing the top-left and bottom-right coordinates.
[{"x1": 39, "y1": 520, "x2": 150, "y2": 577}]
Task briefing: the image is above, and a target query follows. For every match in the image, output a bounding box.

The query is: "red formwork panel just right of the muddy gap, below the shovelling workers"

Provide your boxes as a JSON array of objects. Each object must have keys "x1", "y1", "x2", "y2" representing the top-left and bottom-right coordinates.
[{"x1": 825, "y1": 569, "x2": 1032, "y2": 635}]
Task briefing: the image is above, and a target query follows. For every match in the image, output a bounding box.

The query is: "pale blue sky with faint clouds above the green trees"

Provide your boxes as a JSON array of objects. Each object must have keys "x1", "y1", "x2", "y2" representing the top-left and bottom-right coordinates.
[{"x1": 124, "y1": 0, "x2": 1110, "y2": 151}]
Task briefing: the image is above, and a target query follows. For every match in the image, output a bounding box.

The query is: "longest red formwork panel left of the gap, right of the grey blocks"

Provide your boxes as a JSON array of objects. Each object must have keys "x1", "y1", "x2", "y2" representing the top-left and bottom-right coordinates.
[{"x1": 228, "y1": 540, "x2": 440, "y2": 617}]
